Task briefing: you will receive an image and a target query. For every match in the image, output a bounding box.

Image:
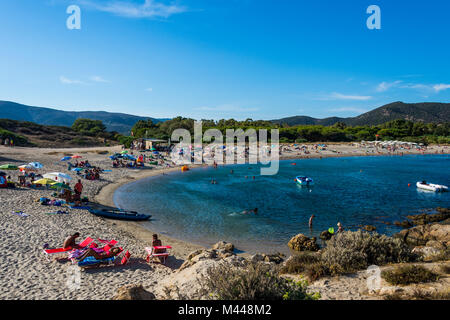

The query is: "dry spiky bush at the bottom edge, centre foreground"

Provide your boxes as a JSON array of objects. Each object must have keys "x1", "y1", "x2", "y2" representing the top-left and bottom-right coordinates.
[{"x1": 200, "y1": 263, "x2": 318, "y2": 300}]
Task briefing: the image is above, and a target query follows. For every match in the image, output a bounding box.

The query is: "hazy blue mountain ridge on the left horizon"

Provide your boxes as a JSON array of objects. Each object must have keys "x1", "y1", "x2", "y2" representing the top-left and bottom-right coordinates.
[{"x1": 0, "y1": 101, "x2": 168, "y2": 134}]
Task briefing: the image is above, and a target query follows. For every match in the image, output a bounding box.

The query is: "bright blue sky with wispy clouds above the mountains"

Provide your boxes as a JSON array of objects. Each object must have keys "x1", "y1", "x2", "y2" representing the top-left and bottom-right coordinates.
[{"x1": 0, "y1": 0, "x2": 450, "y2": 120}]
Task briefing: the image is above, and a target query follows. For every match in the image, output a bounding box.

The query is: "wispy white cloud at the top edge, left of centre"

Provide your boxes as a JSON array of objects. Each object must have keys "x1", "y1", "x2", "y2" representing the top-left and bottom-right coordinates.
[{"x1": 80, "y1": 0, "x2": 187, "y2": 18}]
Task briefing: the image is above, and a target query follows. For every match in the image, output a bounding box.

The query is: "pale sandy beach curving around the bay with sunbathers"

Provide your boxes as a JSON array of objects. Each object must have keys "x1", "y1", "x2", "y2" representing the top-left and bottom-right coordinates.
[{"x1": 0, "y1": 144, "x2": 449, "y2": 300}]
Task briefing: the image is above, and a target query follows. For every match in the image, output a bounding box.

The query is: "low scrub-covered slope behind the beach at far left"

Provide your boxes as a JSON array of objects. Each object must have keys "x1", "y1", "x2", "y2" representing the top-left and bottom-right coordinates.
[{"x1": 0, "y1": 119, "x2": 118, "y2": 148}]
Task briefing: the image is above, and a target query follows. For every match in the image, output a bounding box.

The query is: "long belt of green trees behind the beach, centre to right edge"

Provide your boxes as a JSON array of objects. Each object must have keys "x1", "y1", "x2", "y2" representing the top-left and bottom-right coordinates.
[{"x1": 131, "y1": 117, "x2": 450, "y2": 144}]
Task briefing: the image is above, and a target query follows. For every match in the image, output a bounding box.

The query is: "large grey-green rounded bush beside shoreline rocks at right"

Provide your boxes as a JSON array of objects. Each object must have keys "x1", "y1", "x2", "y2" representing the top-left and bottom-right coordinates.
[{"x1": 322, "y1": 230, "x2": 415, "y2": 273}]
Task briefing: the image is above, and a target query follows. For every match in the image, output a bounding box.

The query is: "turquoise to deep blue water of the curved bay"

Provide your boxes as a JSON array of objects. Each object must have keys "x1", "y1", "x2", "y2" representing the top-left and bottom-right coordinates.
[{"x1": 114, "y1": 155, "x2": 450, "y2": 252}]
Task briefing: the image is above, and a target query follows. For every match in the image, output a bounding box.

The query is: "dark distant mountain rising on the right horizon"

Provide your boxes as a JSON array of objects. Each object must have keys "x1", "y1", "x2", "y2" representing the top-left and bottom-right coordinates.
[{"x1": 272, "y1": 102, "x2": 450, "y2": 126}]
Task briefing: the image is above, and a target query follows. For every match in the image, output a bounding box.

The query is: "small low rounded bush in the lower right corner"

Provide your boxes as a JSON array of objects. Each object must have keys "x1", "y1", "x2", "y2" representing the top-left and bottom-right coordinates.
[{"x1": 381, "y1": 265, "x2": 439, "y2": 285}]
